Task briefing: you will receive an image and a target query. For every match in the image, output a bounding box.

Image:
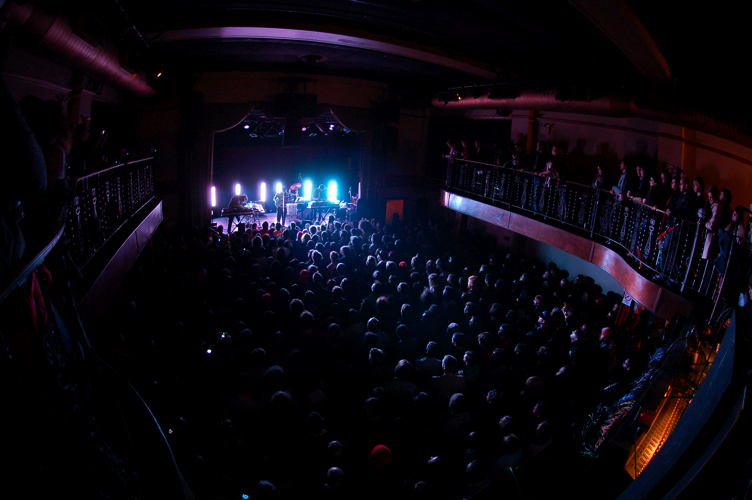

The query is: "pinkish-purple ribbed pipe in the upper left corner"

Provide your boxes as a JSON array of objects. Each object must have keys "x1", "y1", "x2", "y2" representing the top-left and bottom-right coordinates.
[{"x1": 2, "y1": 2, "x2": 156, "y2": 96}]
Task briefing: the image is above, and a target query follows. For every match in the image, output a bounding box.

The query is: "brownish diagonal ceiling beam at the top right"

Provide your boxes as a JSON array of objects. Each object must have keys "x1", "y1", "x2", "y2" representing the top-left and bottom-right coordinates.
[{"x1": 569, "y1": 0, "x2": 668, "y2": 81}]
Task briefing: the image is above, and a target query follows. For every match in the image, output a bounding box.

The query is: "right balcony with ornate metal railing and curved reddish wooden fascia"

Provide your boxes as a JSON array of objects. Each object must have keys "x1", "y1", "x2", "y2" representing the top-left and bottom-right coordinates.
[{"x1": 441, "y1": 158, "x2": 721, "y2": 318}]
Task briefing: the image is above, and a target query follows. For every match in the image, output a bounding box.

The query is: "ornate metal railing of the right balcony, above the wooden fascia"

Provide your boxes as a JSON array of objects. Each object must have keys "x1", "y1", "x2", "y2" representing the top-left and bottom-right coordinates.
[{"x1": 447, "y1": 158, "x2": 719, "y2": 298}]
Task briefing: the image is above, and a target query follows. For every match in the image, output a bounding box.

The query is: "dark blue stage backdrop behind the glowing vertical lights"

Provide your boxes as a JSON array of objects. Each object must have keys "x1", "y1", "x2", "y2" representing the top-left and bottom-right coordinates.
[{"x1": 213, "y1": 133, "x2": 361, "y2": 209}]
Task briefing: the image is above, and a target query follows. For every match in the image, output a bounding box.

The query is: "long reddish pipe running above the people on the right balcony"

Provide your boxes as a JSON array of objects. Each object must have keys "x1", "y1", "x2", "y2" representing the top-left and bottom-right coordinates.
[{"x1": 432, "y1": 87, "x2": 752, "y2": 148}]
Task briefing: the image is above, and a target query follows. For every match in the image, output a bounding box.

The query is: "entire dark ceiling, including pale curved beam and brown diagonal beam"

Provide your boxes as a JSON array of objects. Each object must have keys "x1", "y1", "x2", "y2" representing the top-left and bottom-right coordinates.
[{"x1": 26, "y1": 0, "x2": 752, "y2": 115}]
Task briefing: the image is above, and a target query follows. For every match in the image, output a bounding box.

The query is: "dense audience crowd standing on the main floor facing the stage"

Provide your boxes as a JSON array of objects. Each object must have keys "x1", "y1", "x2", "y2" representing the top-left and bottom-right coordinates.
[{"x1": 99, "y1": 212, "x2": 658, "y2": 499}]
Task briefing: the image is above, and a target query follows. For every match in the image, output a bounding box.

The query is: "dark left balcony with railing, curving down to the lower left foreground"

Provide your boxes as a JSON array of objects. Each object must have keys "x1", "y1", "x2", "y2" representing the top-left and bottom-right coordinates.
[{"x1": 0, "y1": 158, "x2": 193, "y2": 499}]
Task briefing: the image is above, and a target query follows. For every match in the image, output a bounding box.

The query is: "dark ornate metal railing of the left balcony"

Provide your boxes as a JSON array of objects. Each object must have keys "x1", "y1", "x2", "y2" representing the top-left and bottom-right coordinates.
[{"x1": 66, "y1": 158, "x2": 154, "y2": 269}]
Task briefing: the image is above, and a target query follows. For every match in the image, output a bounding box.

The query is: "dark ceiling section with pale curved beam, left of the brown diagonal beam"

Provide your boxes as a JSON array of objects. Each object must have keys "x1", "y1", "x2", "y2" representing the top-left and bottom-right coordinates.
[{"x1": 121, "y1": 0, "x2": 639, "y2": 90}]
